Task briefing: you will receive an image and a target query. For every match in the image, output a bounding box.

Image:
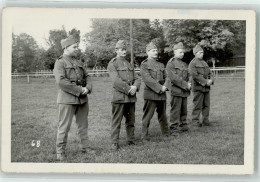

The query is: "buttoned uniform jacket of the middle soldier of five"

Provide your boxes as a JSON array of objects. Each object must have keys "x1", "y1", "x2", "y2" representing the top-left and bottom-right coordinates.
[{"x1": 141, "y1": 58, "x2": 167, "y2": 100}]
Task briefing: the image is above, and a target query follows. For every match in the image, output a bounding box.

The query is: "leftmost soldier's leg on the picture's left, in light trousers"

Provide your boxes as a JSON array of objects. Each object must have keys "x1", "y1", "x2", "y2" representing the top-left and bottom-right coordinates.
[{"x1": 56, "y1": 104, "x2": 76, "y2": 154}]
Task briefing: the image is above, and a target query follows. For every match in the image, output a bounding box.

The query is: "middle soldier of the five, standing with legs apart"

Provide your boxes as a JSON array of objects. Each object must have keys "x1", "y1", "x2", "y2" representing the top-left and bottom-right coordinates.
[{"x1": 141, "y1": 42, "x2": 169, "y2": 140}]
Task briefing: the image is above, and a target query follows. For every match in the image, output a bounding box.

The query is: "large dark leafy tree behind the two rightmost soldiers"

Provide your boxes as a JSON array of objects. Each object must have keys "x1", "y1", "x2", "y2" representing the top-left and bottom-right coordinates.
[{"x1": 162, "y1": 19, "x2": 245, "y2": 63}]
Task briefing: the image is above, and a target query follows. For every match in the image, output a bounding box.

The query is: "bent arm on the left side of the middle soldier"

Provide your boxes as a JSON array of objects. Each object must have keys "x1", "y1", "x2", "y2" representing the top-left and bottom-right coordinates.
[{"x1": 141, "y1": 64, "x2": 162, "y2": 93}]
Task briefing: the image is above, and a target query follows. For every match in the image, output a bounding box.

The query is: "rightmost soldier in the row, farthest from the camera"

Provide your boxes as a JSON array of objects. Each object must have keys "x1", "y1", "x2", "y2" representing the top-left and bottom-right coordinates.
[{"x1": 189, "y1": 45, "x2": 214, "y2": 127}]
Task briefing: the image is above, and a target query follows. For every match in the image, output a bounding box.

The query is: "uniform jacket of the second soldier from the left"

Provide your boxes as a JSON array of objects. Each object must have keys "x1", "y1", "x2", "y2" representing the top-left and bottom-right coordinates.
[{"x1": 107, "y1": 57, "x2": 141, "y2": 103}]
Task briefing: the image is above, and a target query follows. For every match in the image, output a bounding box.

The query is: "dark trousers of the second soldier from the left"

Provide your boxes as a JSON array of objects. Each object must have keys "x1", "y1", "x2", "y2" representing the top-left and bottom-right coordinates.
[{"x1": 111, "y1": 103, "x2": 135, "y2": 143}]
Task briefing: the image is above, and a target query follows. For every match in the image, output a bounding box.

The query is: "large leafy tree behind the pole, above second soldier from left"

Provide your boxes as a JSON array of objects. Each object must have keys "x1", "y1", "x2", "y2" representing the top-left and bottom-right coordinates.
[{"x1": 85, "y1": 19, "x2": 153, "y2": 67}]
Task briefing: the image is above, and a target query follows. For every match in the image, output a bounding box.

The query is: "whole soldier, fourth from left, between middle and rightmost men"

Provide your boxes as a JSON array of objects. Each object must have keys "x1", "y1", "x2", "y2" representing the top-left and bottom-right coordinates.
[{"x1": 166, "y1": 42, "x2": 191, "y2": 135}]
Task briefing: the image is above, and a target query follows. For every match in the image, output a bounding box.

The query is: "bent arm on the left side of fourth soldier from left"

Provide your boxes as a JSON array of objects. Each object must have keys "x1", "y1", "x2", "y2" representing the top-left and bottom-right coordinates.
[{"x1": 166, "y1": 63, "x2": 188, "y2": 90}]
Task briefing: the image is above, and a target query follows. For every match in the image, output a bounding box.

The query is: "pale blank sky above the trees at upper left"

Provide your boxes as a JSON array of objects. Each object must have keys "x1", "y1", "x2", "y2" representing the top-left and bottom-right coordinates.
[{"x1": 12, "y1": 9, "x2": 91, "y2": 49}]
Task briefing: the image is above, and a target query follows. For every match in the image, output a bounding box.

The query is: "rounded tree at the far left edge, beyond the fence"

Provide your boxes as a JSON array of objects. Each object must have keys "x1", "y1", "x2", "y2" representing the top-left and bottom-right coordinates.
[{"x1": 12, "y1": 33, "x2": 38, "y2": 72}]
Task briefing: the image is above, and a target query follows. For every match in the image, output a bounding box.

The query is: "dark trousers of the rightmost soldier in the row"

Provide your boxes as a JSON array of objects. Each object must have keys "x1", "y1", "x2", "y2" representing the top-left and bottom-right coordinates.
[{"x1": 192, "y1": 92, "x2": 210, "y2": 123}]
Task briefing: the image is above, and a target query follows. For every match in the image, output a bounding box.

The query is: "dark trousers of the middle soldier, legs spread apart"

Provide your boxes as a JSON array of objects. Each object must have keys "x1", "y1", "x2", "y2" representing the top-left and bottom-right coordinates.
[{"x1": 142, "y1": 100, "x2": 169, "y2": 139}]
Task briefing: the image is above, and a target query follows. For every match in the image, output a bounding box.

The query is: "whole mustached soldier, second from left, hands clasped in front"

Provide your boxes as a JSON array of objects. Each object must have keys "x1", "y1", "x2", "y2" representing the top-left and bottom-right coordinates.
[{"x1": 107, "y1": 40, "x2": 141, "y2": 150}]
